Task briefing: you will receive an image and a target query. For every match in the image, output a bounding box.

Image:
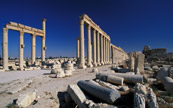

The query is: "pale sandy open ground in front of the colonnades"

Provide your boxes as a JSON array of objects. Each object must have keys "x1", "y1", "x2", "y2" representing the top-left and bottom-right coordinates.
[{"x1": 0, "y1": 65, "x2": 111, "y2": 108}]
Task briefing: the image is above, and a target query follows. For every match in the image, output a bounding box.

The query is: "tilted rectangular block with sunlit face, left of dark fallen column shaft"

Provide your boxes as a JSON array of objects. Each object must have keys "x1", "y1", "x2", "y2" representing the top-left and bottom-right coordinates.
[{"x1": 67, "y1": 84, "x2": 87, "y2": 108}]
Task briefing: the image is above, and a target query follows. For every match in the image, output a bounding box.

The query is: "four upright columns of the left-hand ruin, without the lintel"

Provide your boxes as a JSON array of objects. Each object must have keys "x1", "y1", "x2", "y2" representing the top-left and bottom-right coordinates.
[{"x1": 2, "y1": 19, "x2": 46, "y2": 70}]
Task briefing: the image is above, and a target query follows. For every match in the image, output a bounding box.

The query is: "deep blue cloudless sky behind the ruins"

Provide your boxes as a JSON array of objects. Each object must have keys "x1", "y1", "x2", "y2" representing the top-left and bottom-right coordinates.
[{"x1": 0, "y1": 0, "x2": 173, "y2": 57}]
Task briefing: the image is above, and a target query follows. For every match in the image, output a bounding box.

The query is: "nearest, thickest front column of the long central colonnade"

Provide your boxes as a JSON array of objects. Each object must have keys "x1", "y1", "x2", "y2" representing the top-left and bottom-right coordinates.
[{"x1": 79, "y1": 20, "x2": 86, "y2": 69}]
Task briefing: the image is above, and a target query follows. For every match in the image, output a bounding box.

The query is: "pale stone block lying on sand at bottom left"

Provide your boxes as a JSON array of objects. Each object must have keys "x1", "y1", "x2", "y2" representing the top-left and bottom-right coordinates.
[{"x1": 16, "y1": 92, "x2": 36, "y2": 107}]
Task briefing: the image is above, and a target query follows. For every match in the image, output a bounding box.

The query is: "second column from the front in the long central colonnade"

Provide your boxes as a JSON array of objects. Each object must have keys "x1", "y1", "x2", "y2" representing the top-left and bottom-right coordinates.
[{"x1": 87, "y1": 25, "x2": 93, "y2": 67}]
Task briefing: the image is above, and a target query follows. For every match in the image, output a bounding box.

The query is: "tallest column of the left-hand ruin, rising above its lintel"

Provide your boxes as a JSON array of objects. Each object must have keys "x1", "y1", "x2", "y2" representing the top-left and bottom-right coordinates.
[{"x1": 41, "y1": 19, "x2": 46, "y2": 61}]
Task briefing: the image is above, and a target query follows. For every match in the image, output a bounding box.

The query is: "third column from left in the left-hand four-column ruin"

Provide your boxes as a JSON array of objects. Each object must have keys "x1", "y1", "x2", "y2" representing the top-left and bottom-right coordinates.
[{"x1": 32, "y1": 34, "x2": 36, "y2": 64}]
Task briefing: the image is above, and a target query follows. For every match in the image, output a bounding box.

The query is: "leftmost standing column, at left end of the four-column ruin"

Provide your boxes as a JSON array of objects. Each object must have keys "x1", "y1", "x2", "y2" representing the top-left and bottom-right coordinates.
[{"x1": 2, "y1": 28, "x2": 8, "y2": 70}]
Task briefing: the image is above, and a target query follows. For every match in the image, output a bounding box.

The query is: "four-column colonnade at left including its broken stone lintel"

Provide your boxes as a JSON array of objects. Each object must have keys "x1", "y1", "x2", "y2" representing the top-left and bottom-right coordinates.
[{"x1": 2, "y1": 19, "x2": 46, "y2": 70}]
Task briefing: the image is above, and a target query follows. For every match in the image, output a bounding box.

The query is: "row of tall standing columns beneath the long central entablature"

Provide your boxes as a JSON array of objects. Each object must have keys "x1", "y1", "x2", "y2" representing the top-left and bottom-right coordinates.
[{"x1": 77, "y1": 20, "x2": 110, "y2": 68}]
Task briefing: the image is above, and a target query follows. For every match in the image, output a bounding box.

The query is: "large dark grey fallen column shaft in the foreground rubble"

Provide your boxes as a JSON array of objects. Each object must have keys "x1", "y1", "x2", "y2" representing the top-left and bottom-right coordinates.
[{"x1": 77, "y1": 80, "x2": 120, "y2": 104}]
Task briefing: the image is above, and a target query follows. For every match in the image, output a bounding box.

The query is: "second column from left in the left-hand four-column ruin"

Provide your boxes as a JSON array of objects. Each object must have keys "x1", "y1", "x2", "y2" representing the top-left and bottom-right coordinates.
[{"x1": 19, "y1": 31, "x2": 24, "y2": 70}]
